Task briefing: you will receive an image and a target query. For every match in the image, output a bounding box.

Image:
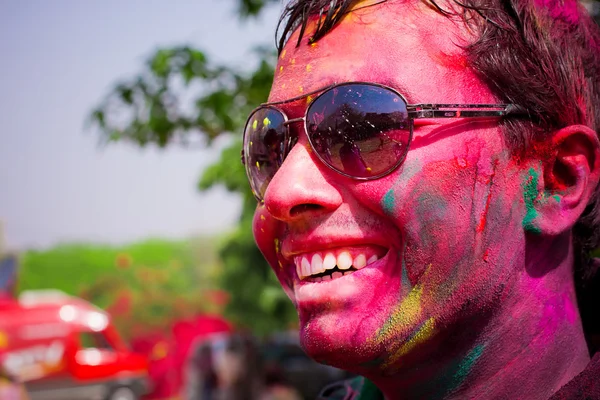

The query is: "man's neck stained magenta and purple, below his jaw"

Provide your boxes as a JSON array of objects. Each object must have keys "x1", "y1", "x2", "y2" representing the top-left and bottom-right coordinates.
[{"x1": 366, "y1": 236, "x2": 589, "y2": 400}]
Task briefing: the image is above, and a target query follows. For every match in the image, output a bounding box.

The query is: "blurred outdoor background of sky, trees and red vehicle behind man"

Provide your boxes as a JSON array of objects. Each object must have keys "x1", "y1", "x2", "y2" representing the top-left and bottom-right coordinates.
[{"x1": 0, "y1": 0, "x2": 599, "y2": 400}]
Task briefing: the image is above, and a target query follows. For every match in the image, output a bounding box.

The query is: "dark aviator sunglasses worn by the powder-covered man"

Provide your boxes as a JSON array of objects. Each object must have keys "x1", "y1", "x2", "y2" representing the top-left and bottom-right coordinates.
[{"x1": 242, "y1": 82, "x2": 525, "y2": 202}]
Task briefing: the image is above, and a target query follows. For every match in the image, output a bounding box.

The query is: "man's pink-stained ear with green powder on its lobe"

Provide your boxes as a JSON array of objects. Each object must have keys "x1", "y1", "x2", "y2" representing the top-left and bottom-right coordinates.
[{"x1": 535, "y1": 125, "x2": 600, "y2": 235}]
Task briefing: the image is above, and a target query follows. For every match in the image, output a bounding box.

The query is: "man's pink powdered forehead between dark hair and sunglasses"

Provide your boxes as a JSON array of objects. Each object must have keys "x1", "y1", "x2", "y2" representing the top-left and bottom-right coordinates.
[{"x1": 269, "y1": 1, "x2": 492, "y2": 103}]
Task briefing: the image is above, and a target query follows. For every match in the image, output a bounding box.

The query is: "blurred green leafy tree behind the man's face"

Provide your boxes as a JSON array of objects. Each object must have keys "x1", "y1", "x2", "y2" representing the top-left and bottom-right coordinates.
[{"x1": 91, "y1": 0, "x2": 296, "y2": 333}]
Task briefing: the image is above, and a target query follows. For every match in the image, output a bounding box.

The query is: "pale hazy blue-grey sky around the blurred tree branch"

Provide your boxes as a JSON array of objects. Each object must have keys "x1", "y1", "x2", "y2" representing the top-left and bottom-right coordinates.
[{"x1": 0, "y1": 0, "x2": 280, "y2": 250}]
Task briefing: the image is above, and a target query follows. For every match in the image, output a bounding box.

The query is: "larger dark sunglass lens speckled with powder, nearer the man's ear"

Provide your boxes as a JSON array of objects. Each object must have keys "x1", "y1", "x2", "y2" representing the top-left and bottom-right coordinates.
[{"x1": 306, "y1": 84, "x2": 410, "y2": 178}]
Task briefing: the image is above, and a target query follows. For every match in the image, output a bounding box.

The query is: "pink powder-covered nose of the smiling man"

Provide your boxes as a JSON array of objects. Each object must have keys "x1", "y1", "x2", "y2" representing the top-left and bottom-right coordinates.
[{"x1": 264, "y1": 136, "x2": 345, "y2": 222}]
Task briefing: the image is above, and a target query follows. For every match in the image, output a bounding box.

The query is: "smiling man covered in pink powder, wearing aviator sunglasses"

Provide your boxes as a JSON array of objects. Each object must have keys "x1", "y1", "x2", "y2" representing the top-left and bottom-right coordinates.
[{"x1": 243, "y1": 0, "x2": 600, "y2": 399}]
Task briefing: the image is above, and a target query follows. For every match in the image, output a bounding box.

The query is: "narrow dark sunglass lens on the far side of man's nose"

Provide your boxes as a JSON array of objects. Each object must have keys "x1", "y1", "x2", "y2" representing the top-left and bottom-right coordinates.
[{"x1": 244, "y1": 107, "x2": 287, "y2": 199}]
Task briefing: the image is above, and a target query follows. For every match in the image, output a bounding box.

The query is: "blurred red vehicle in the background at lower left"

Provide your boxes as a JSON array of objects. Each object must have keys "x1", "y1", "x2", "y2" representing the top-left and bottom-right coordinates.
[{"x1": 0, "y1": 291, "x2": 148, "y2": 400}]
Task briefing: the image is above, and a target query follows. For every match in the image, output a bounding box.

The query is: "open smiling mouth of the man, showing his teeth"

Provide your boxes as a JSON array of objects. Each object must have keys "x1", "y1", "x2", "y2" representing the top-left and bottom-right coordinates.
[{"x1": 294, "y1": 246, "x2": 387, "y2": 282}]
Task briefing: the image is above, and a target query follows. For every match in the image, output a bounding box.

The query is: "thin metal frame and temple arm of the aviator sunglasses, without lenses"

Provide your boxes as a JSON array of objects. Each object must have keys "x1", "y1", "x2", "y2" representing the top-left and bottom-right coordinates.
[{"x1": 241, "y1": 81, "x2": 528, "y2": 201}]
